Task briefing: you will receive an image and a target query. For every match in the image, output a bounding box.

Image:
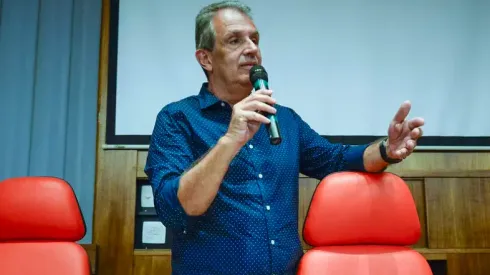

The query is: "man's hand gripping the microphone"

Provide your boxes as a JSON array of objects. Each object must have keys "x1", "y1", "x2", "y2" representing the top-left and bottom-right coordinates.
[{"x1": 226, "y1": 90, "x2": 276, "y2": 146}]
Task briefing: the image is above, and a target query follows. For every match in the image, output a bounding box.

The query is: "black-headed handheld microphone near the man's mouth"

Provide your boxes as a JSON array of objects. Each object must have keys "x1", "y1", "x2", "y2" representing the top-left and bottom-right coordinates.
[{"x1": 250, "y1": 65, "x2": 282, "y2": 145}]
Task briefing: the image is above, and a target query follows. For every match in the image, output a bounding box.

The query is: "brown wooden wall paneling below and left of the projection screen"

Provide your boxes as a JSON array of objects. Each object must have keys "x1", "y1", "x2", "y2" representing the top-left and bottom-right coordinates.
[{"x1": 93, "y1": 0, "x2": 490, "y2": 275}]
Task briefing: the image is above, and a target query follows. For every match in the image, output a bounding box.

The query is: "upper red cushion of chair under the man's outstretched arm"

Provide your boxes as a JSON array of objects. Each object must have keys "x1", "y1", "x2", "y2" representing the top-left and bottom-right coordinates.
[{"x1": 303, "y1": 172, "x2": 421, "y2": 247}]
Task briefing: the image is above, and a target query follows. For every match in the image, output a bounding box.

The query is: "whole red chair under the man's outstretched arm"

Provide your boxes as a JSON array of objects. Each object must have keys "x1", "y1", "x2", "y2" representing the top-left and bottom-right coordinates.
[{"x1": 297, "y1": 172, "x2": 432, "y2": 275}]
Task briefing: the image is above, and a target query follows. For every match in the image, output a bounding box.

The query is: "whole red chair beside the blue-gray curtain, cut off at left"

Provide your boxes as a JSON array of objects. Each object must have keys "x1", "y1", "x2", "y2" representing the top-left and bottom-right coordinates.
[{"x1": 0, "y1": 177, "x2": 90, "y2": 275}]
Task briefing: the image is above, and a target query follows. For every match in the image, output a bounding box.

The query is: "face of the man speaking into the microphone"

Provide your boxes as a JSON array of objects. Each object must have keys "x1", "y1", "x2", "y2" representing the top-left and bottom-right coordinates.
[{"x1": 211, "y1": 9, "x2": 262, "y2": 87}]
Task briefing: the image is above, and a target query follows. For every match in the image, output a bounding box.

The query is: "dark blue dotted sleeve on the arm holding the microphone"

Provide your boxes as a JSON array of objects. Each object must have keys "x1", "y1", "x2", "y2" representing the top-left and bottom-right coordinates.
[{"x1": 145, "y1": 109, "x2": 197, "y2": 231}]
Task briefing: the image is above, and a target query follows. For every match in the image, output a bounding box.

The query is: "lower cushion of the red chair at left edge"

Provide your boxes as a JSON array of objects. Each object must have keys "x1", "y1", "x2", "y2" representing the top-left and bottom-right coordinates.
[{"x1": 0, "y1": 242, "x2": 90, "y2": 275}]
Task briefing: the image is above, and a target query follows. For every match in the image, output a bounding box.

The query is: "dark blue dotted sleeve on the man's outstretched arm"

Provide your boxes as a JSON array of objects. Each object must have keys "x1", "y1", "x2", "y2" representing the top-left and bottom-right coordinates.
[{"x1": 293, "y1": 111, "x2": 369, "y2": 180}]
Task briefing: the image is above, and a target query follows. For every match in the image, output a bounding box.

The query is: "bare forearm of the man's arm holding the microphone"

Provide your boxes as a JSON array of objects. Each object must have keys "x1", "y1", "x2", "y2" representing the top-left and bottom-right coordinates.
[{"x1": 177, "y1": 137, "x2": 243, "y2": 216}]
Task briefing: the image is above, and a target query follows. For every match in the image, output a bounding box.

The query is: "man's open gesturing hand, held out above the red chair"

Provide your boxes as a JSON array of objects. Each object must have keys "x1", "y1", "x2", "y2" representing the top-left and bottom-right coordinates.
[{"x1": 386, "y1": 101, "x2": 424, "y2": 162}]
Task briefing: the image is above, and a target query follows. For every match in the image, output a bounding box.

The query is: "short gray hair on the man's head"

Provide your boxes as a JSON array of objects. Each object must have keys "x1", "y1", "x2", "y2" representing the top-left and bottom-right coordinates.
[{"x1": 196, "y1": 0, "x2": 252, "y2": 51}]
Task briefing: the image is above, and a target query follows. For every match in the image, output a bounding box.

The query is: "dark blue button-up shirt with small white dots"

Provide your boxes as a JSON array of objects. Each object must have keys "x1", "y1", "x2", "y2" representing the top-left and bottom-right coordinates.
[{"x1": 145, "y1": 83, "x2": 367, "y2": 275}]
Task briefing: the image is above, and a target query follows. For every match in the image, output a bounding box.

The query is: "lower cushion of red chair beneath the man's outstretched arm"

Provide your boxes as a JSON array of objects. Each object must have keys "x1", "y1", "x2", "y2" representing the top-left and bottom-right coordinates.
[{"x1": 298, "y1": 245, "x2": 432, "y2": 275}]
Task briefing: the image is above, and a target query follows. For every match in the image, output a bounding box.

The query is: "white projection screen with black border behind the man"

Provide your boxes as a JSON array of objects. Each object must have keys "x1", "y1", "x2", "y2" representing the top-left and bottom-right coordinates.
[{"x1": 106, "y1": 0, "x2": 490, "y2": 150}]
